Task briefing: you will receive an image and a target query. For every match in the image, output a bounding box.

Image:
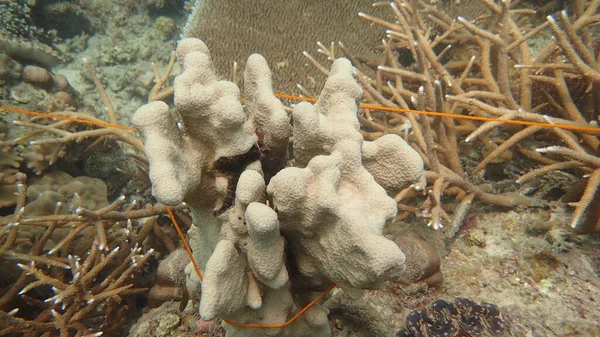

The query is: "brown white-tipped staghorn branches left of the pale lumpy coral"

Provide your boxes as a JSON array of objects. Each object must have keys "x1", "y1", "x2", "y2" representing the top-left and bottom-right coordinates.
[{"x1": 0, "y1": 59, "x2": 184, "y2": 337}]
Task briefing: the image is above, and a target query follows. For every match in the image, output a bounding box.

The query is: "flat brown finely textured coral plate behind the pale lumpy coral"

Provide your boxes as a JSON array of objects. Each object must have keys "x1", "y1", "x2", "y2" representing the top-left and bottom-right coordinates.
[{"x1": 182, "y1": 0, "x2": 387, "y2": 94}]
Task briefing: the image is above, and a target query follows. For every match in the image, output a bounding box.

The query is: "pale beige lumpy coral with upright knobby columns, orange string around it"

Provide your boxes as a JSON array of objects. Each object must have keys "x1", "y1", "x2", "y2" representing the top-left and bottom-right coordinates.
[{"x1": 133, "y1": 39, "x2": 423, "y2": 336}]
